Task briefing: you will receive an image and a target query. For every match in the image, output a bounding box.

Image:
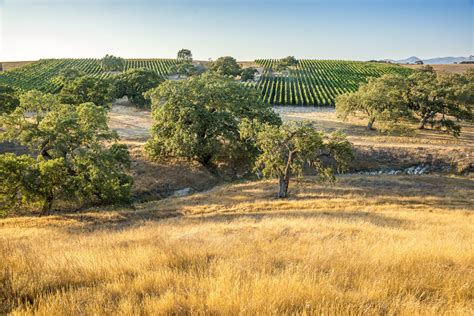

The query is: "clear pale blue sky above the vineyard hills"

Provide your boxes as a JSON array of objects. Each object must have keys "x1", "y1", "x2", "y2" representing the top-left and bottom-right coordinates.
[{"x1": 0, "y1": 0, "x2": 474, "y2": 61}]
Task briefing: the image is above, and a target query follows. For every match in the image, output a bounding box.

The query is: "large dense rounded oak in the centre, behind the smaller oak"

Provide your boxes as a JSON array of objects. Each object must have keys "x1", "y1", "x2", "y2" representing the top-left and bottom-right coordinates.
[{"x1": 146, "y1": 73, "x2": 281, "y2": 166}]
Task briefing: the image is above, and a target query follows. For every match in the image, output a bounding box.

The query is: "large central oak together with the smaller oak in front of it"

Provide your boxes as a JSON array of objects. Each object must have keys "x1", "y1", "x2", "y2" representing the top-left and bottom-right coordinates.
[{"x1": 145, "y1": 72, "x2": 352, "y2": 198}]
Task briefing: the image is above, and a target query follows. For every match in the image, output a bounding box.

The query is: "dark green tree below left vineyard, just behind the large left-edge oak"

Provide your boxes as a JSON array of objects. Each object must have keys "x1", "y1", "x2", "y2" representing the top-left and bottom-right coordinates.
[{"x1": 59, "y1": 76, "x2": 114, "y2": 107}]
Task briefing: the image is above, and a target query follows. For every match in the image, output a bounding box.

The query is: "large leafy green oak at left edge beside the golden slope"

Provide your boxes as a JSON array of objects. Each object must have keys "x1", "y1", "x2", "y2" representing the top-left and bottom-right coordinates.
[{"x1": 0, "y1": 91, "x2": 132, "y2": 213}]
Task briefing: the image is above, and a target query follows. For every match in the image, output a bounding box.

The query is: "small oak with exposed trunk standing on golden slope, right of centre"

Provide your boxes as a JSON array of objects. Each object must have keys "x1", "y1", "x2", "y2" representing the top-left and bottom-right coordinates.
[{"x1": 244, "y1": 123, "x2": 353, "y2": 198}]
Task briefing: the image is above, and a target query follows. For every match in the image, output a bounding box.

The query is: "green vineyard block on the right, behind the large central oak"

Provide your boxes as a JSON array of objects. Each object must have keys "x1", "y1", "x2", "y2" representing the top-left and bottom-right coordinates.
[{"x1": 252, "y1": 59, "x2": 411, "y2": 105}]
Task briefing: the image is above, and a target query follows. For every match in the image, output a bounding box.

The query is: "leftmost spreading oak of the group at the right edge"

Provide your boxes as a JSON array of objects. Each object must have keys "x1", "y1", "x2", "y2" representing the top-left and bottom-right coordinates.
[{"x1": 336, "y1": 75, "x2": 408, "y2": 130}]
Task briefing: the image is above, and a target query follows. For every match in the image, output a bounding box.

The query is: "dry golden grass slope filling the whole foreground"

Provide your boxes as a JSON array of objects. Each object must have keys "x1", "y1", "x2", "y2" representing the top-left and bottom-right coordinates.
[{"x1": 0, "y1": 176, "x2": 474, "y2": 315}]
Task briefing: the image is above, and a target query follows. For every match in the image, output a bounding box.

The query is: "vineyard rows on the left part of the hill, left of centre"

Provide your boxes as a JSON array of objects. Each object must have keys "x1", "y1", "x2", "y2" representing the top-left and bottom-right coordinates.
[{"x1": 0, "y1": 59, "x2": 175, "y2": 93}]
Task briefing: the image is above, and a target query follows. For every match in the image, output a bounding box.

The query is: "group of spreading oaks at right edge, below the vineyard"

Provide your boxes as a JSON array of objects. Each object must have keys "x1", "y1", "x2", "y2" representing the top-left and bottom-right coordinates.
[{"x1": 336, "y1": 66, "x2": 474, "y2": 137}]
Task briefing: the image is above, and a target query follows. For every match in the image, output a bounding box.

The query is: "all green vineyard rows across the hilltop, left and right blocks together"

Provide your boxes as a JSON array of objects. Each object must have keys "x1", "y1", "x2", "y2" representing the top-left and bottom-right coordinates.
[{"x1": 0, "y1": 59, "x2": 412, "y2": 105}]
